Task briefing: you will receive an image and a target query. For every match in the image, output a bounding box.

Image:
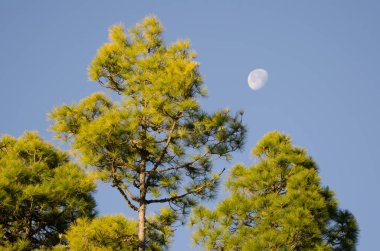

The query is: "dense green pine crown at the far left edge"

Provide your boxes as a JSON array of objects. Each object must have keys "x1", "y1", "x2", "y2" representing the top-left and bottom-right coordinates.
[{"x1": 0, "y1": 132, "x2": 95, "y2": 250}]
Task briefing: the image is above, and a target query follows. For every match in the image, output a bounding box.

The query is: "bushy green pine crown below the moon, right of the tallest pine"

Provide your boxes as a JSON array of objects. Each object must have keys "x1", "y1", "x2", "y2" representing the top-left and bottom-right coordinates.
[{"x1": 191, "y1": 132, "x2": 358, "y2": 250}]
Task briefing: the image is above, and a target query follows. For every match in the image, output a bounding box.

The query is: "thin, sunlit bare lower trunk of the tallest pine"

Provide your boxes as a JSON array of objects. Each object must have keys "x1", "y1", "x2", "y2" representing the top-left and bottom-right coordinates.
[{"x1": 139, "y1": 161, "x2": 146, "y2": 251}]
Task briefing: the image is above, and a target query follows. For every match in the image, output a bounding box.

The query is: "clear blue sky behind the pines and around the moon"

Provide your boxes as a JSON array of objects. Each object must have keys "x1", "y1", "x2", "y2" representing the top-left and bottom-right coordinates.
[{"x1": 0, "y1": 0, "x2": 380, "y2": 250}]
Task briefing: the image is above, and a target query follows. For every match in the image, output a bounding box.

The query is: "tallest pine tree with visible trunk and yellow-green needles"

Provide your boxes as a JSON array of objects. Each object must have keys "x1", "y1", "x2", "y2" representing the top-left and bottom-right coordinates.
[{"x1": 50, "y1": 17, "x2": 245, "y2": 250}]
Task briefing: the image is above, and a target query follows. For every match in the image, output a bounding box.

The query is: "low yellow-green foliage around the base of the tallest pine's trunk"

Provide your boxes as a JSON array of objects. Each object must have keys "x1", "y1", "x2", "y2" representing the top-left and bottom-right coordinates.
[{"x1": 65, "y1": 208, "x2": 176, "y2": 251}]
